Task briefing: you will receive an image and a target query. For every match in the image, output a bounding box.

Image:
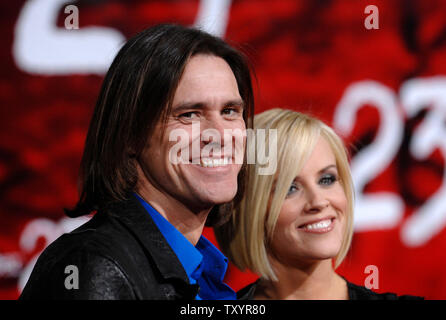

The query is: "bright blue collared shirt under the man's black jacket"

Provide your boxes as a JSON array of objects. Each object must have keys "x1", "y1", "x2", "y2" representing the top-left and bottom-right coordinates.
[{"x1": 135, "y1": 194, "x2": 236, "y2": 300}]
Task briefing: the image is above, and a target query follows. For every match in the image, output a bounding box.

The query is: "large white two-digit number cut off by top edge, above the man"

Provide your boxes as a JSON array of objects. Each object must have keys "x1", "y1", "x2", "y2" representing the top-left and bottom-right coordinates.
[{"x1": 13, "y1": 0, "x2": 231, "y2": 75}]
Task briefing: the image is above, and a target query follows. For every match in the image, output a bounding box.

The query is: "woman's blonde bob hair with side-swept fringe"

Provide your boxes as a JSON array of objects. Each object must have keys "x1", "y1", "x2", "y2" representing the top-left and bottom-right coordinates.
[{"x1": 215, "y1": 109, "x2": 354, "y2": 280}]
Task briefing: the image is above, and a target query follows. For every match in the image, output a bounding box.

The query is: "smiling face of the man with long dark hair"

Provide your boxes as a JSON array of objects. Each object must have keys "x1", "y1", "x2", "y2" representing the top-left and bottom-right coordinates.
[{"x1": 139, "y1": 54, "x2": 246, "y2": 210}]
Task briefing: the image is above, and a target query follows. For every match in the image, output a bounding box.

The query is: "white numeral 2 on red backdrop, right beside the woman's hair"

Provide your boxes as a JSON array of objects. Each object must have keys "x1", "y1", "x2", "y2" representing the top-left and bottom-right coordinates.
[{"x1": 333, "y1": 81, "x2": 404, "y2": 231}]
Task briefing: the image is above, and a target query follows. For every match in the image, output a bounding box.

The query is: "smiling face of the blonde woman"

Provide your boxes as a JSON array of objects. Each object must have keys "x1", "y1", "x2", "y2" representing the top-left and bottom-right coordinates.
[{"x1": 271, "y1": 137, "x2": 348, "y2": 265}]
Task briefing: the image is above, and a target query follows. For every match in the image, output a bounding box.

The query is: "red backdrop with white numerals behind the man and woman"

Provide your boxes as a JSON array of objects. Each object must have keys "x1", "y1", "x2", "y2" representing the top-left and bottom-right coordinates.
[{"x1": 0, "y1": 0, "x2": 446, "y2": 299}]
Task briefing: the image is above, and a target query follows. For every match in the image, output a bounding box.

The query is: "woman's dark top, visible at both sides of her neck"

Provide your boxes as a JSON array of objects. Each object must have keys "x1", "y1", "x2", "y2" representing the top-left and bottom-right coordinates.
[{"x1": 237, "y1": 280, "x2": 424, "y2": 300}]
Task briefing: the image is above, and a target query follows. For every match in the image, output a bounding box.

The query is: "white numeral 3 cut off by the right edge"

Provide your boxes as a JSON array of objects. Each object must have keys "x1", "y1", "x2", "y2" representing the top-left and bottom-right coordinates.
[{"x1": 400, "y1": 77, "x2": 446, "y2": 246}]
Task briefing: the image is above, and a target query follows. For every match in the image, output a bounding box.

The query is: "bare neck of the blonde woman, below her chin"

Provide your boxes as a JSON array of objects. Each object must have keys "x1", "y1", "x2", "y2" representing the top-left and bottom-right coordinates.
[{"x1": 254, "y1": 259, "x2": 348, "y2": 300}]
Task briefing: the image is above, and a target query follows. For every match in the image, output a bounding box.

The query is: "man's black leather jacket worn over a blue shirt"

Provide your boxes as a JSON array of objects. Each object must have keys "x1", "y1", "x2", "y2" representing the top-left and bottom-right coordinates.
[{"x1": 19, "y1": 197, "x2": 198, "y2": 300}]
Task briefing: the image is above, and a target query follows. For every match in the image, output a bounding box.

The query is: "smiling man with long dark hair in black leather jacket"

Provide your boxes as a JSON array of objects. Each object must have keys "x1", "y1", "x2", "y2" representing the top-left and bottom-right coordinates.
[{"x1": 20, "y1": 25, "x2": 253, "y2": 299}]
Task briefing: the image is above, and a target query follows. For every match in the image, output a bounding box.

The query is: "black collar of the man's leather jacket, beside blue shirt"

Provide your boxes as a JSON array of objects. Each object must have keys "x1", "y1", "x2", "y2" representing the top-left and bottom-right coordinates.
[{"x1": 107, "y1": 196, "x2": 193, "y2": 284}]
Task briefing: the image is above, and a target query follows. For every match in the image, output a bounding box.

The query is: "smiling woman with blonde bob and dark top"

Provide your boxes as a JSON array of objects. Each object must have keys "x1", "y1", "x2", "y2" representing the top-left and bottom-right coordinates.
[{"x1": 216, "y1": 109, "x2": 424, "y2": 300}]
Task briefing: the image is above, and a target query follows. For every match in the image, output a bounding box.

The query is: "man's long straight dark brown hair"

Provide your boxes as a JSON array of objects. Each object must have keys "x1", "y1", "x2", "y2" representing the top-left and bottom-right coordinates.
[{"x1": 65, "y1": 24, "x2": 254, "y2": 225}]
